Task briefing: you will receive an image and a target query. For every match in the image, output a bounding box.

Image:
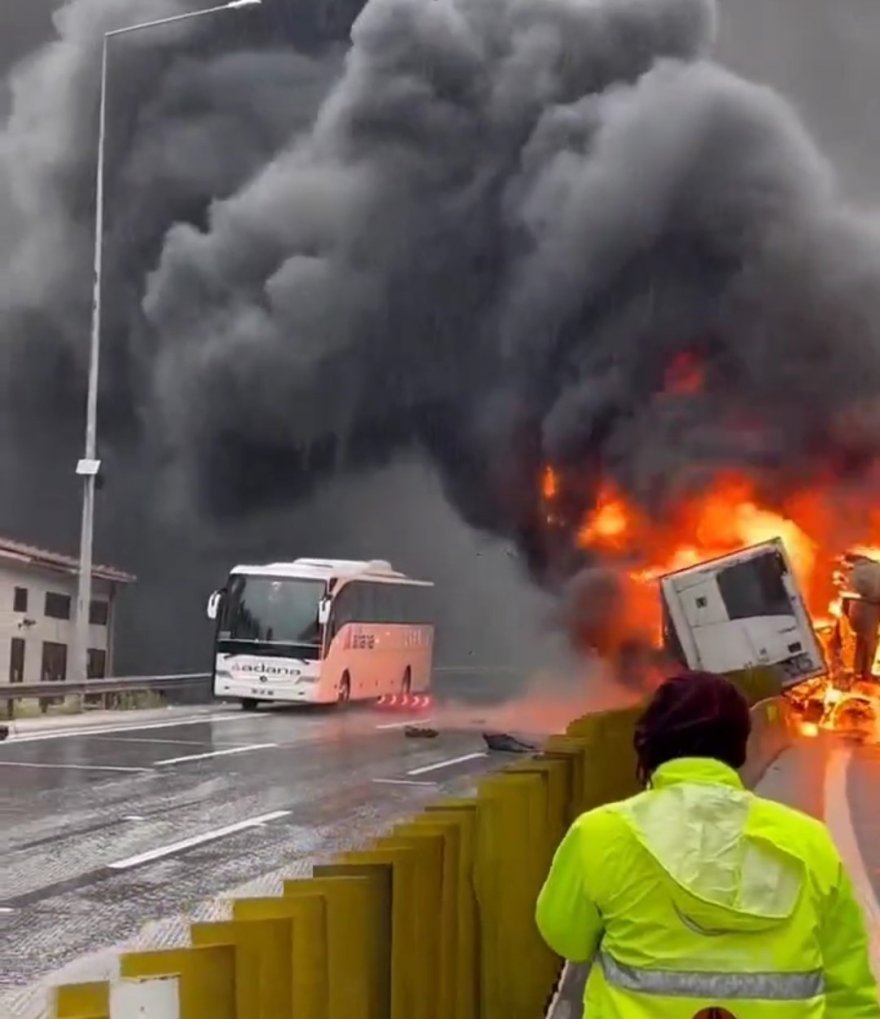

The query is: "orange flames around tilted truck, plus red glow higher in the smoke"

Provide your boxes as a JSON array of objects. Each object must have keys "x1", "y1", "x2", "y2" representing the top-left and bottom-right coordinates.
[{"x1": 541, "y1": 353, "x2": 880, "y2": 738}]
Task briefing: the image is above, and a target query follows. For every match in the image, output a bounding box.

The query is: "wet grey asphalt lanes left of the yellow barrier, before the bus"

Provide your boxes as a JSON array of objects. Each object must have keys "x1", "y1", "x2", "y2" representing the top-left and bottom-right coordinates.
[{"x1": 0, "y1": 692, "x2": 505, "y2": 991}]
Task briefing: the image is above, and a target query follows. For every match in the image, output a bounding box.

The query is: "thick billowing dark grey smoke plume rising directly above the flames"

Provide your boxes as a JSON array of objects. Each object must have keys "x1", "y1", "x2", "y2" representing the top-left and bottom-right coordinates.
[{"x1": 137, "y1": 0, "x2": 880, "y2": 569}]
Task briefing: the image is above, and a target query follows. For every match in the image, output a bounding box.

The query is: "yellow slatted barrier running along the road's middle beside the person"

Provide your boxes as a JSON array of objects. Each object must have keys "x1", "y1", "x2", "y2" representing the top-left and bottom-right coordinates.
[{"x1": 54, "y1": 710, "x2": 651, "y2": 1019}]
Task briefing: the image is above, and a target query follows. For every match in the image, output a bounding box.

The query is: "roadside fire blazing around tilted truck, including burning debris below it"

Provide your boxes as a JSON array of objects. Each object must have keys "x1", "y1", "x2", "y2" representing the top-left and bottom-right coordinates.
[{"x1": 541, "y1": 466, "x2": 880, "y2": 737}]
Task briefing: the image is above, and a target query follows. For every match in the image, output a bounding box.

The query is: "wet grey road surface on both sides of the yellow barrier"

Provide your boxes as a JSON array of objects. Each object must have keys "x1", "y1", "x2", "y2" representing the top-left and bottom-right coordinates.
[{"x1": 0, "y1": 688, "x2": 880, "y2": 1019}]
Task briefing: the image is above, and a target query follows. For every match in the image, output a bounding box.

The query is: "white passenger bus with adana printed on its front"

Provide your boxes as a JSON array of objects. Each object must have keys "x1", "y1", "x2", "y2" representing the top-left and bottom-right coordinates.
[{"x1": 208, "y1": 558, "x2": 434, "y2": 710}]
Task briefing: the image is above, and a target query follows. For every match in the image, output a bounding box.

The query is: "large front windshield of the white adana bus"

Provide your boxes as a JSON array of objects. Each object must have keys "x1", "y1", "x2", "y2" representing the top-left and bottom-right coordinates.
[{"x1": 218, "y1": 574, "x2": 326, "y2": 647}]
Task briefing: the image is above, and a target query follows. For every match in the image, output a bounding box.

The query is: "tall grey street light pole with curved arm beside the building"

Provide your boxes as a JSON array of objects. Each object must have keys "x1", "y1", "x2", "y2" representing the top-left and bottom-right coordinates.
[{"x1": 73, "y1": 0, "x2": 262, "y2": 680}]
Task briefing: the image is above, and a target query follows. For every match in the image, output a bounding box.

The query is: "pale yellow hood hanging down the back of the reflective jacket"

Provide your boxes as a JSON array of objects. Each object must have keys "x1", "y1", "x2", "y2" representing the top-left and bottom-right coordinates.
[{"x1": 620, "y1": 758, "x2": 806, "y2": 934}]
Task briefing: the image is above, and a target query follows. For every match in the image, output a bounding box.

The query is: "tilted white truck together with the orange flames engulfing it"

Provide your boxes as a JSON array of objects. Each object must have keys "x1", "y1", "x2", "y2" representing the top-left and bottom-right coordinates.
[{"x1": 540, "y1": 466, "x2": 880, "y2": 737}]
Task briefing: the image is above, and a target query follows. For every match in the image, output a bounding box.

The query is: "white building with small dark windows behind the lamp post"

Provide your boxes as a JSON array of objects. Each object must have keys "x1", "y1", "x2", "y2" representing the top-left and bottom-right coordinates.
[{"x1": 0, "y1": 537, "x2": 134, "y2": 688}]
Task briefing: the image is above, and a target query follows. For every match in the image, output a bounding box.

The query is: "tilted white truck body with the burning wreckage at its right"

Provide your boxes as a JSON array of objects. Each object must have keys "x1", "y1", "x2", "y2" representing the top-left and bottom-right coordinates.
[{"x1": 659, "y1": 538, "x2": 880, "y2": 733}]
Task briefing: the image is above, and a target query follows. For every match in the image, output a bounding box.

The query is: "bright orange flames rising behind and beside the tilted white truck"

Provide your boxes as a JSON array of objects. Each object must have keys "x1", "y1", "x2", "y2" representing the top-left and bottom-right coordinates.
[{"x1": 543, "y1": 462, "x2": 880, "y2": 725}]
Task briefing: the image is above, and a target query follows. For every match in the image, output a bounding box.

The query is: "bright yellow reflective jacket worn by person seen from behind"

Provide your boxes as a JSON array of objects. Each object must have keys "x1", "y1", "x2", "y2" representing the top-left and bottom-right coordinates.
[{"x1": 537, "y1": 758, "x2": 880, "y2": 1019}]
